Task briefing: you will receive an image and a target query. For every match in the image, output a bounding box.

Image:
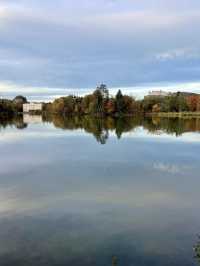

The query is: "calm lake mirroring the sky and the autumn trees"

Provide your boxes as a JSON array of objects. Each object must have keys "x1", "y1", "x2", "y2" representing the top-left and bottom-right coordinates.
[{"x1": 0, "y1": 115, "x2": 200, "y2": 266}]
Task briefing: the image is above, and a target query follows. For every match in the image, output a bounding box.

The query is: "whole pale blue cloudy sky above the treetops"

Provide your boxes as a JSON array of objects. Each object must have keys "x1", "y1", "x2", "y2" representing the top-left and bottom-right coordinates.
[{"x1": 0, "y1": 0, "x2": 200, "y2": 100}]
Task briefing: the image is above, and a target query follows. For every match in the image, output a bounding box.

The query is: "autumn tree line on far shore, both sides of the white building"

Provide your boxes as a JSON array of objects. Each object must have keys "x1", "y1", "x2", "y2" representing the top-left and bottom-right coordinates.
[{"x1": 0, "y1": 84, "x2": 200, "y2": 116}]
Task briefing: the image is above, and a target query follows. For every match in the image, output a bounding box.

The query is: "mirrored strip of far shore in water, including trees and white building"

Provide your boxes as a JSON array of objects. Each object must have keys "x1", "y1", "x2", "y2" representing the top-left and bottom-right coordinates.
[{"x1": 0, "y1": 114, "x2": 200, "y2": 144}]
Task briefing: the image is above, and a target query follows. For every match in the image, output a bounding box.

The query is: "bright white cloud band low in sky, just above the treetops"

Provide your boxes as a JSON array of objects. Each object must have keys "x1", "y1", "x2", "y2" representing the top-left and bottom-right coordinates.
[{"x1": 0, "y1": 79, "x2": 200, "y2": 102}]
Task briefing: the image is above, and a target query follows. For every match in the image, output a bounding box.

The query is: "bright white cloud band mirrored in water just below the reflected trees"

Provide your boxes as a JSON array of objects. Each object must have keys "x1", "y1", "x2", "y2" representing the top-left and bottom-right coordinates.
[{"x1": 0, "y1": 123, "x2": 200, "y2": 145}]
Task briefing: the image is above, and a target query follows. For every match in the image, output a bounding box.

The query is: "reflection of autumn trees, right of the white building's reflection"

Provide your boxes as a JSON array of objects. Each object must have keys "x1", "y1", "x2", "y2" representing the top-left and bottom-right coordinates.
[{"x1": 45, "y1": 115, "x2": 200, "y2": 144}]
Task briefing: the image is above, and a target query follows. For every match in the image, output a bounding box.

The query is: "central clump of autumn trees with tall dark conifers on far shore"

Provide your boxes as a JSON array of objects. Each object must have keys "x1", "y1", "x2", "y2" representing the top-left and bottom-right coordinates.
[{"x1": 44, "y1": 84, "x2": 141, "y2": 115}]
